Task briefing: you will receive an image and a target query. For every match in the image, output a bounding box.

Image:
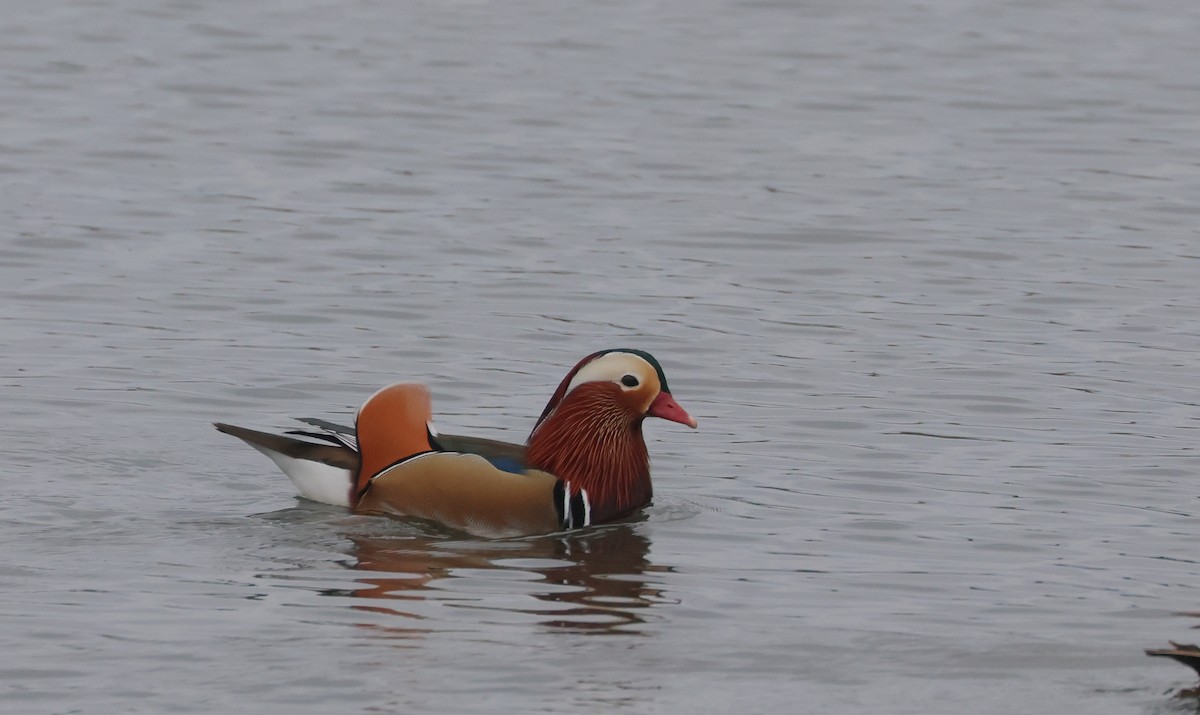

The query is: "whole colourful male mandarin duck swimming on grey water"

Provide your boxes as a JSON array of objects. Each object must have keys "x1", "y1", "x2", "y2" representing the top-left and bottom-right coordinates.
[{"x1": 216, "y1": 349, "x2": 696, "y2": 536}]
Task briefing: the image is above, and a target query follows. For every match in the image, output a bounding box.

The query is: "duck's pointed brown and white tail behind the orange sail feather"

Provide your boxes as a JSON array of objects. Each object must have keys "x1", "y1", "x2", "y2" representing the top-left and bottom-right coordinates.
[{"x1": 214, "y1": 422, "x2": 359, "y2": 506}]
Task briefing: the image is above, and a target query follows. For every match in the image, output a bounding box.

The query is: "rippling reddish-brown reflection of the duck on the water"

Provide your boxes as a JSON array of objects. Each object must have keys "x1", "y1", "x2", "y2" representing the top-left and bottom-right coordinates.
[{"x1": 348, "y1": 523, "x2": 670, "y2": 633}]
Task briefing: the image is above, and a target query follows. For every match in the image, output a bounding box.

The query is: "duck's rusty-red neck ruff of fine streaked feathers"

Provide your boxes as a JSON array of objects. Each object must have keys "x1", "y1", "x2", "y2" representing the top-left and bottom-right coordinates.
[{"x1": 526, "y1": 385, "x2": 653, "y2": 523}]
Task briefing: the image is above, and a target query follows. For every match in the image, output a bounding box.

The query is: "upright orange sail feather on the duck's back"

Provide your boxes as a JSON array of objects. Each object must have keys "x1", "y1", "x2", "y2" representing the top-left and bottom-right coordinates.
[{"x1": 354, "y1": 383, "x2": 437, "y2": 494}]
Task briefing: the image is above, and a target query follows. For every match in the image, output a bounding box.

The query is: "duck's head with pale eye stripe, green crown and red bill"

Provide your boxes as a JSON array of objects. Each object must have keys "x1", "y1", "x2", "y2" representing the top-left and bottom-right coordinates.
[{"x1": 534, "y1": 348, "x2": 696, "y2": 432}]
